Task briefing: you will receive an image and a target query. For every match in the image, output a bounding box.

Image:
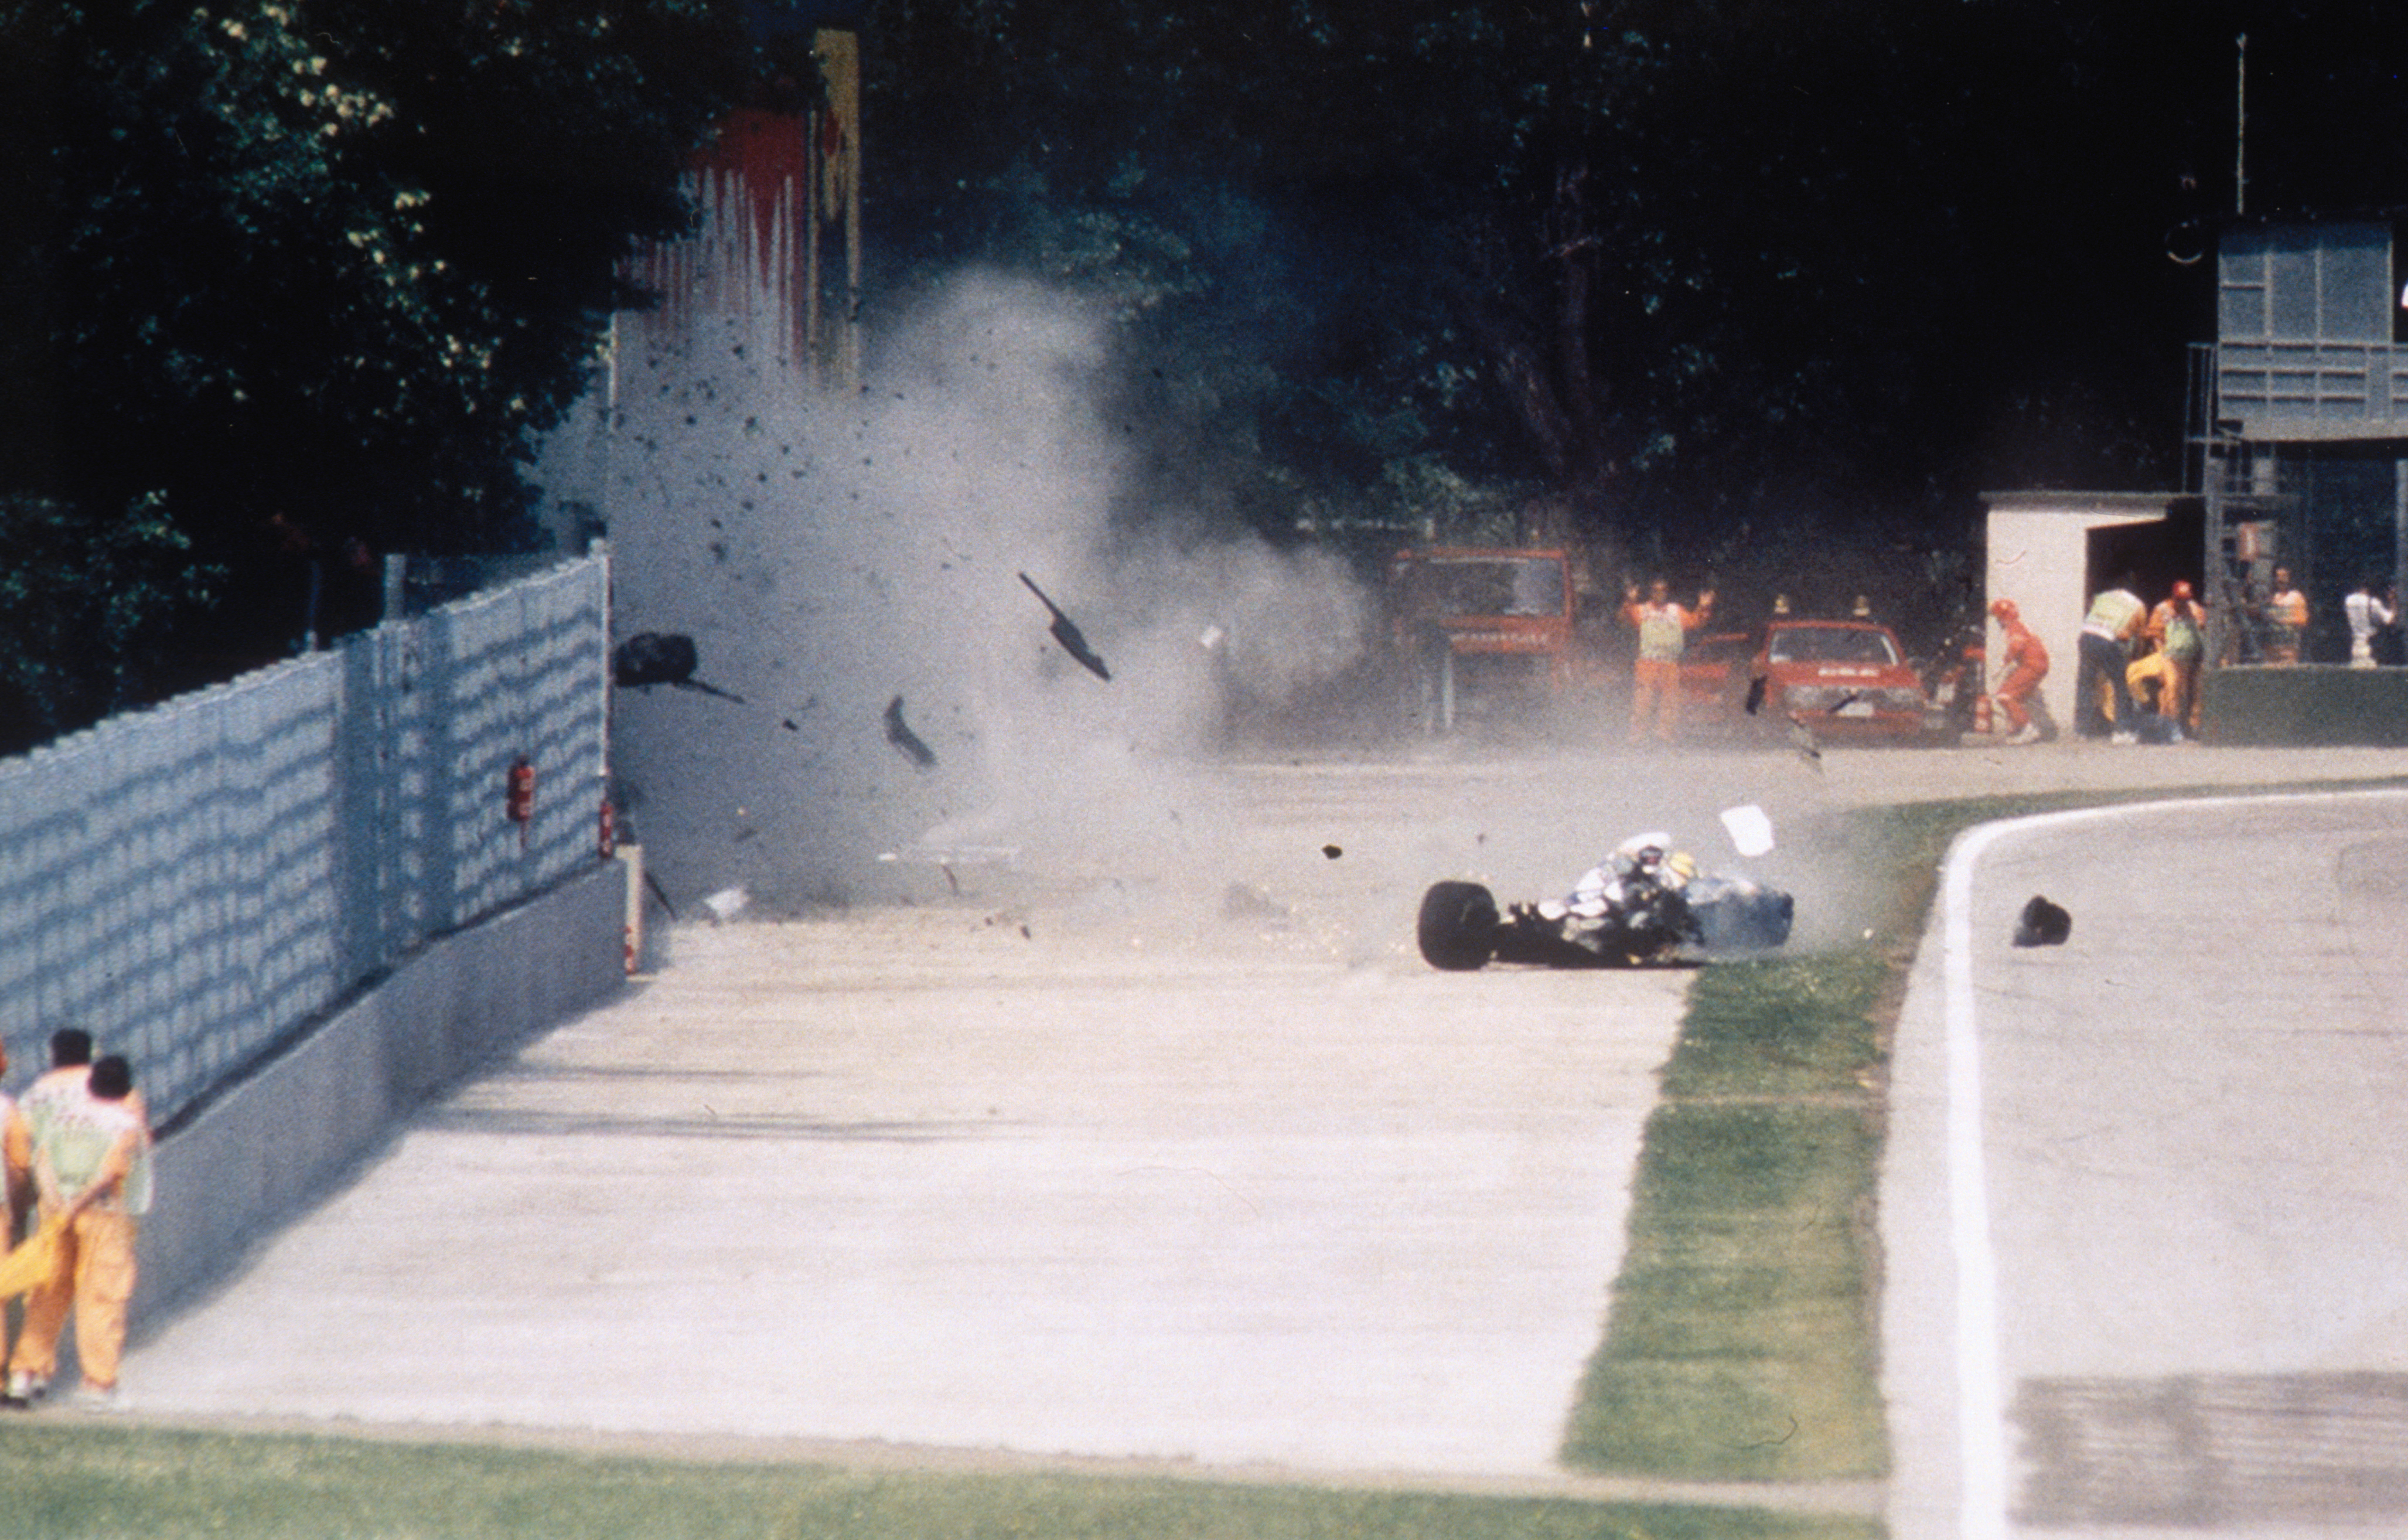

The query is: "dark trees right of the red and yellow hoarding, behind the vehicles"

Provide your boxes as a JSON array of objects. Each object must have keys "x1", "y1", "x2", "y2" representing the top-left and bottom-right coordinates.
[{"x1": 867, "y1": 0, "x2": 2408, "y2": 597}]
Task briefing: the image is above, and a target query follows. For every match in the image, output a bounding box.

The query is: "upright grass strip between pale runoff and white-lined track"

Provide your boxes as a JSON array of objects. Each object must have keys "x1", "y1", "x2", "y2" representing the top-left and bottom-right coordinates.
[{"x1": 1563, "y1": 800, "x2": 2056, "y2": 1480}]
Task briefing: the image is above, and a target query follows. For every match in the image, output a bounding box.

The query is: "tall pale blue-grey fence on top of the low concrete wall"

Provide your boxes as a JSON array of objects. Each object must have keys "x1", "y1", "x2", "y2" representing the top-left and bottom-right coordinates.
[{"x1": 0, "y1": 557, "x2": 609, "y2": 1126}]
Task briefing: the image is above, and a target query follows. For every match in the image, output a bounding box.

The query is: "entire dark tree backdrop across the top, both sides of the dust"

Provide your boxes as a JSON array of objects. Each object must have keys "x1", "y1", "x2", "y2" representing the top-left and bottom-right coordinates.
[{"x1": 0, "y1": 0, "x2": 2408, "y2": 742}]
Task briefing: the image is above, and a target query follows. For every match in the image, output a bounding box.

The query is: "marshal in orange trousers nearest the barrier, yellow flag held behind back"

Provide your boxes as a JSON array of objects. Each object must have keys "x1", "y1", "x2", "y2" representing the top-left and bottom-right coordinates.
[{"x1": 7, "y1": 1053, "x2": 152, "y2": 1408}]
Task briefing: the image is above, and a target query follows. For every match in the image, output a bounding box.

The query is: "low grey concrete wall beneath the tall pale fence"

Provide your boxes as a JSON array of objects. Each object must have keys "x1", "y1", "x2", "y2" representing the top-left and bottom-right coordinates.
[{"x1": 132, "y1": 860, "x2": 629, "y2": 1330}]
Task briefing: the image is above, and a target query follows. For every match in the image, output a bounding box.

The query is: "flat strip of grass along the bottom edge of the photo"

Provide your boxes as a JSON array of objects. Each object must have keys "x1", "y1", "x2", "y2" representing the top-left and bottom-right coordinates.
[{"x1": 0, "y1": 1422, "x2": 1881, "y2": 1540}]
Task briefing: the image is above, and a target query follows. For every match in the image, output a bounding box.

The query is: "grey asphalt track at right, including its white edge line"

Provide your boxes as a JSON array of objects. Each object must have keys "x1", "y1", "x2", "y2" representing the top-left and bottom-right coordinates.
[{"x1": 1883, "y1": 791, "x2": 2408, "y2": 1540}]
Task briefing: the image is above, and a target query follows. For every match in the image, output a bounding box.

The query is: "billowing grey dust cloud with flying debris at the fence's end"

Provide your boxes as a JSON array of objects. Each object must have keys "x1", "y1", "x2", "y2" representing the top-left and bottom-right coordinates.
[{"x1": 573, "y1": 277, "x2": 1370, "y2": 911}]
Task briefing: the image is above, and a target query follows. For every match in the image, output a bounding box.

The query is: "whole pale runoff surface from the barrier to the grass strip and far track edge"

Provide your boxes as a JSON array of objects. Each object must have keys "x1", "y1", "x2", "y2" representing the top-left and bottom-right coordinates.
[{"x1": 125, "y1": 745, "x2": 2408, "y2": 1506}]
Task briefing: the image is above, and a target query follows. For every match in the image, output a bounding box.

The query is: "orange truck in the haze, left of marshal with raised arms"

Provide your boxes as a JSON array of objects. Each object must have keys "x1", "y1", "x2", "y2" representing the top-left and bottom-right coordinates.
[{"x1": 1389, "y1": 544, "x2": 1580, "y2": 732}]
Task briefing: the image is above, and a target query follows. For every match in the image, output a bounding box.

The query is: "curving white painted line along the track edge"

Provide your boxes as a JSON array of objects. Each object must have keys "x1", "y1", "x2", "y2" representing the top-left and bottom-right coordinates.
[{"x1": 1941, "y1": 791, "x2": 2401, "y2": 1540}]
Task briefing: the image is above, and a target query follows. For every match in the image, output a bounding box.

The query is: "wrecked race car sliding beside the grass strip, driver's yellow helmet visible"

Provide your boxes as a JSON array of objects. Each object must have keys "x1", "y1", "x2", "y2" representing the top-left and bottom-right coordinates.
[{"x1": 1416, "y1": 834, "x2": 1794, "y2": 974}]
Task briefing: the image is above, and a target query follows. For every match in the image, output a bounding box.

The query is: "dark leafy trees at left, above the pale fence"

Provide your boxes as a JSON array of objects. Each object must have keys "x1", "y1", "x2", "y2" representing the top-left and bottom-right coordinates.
[{"x1": 0, "y1": 0, "x2": 751, "y2": 747}]
